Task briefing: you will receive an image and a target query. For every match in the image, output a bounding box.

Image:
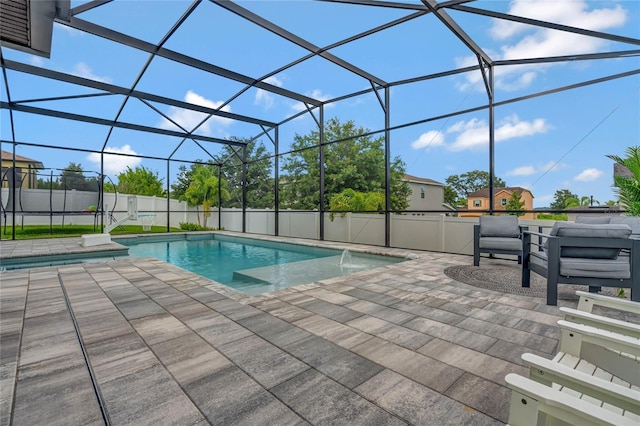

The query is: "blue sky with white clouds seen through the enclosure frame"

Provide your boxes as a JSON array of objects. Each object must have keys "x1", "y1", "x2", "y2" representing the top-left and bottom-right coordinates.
[{"x1": 0, "y1": 0, "x2": 640, "y2": 207}]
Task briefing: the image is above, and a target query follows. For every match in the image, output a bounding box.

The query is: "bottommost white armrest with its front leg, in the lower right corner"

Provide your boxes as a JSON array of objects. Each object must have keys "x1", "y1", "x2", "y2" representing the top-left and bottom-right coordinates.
[{"x1": 505, "y1": 373, "x2": 637, "y2": 426}]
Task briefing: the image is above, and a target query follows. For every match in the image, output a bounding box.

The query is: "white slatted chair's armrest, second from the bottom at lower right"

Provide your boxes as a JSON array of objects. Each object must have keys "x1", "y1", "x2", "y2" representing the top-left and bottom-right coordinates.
[{"x1": 522, "y1": 353, "x2": 640, "y2": 414}]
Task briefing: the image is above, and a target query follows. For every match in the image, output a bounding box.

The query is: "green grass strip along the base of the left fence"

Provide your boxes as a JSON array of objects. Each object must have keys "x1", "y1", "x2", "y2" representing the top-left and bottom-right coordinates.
[{"x1": 2, "y1": 225, "x2": 181, "y2": 240}]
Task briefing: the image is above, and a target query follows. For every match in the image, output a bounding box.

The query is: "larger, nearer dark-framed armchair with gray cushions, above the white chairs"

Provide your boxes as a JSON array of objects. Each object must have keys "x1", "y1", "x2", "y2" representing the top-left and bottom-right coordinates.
[{"x1": 522, "y1": 222, "x2": 640, "y2": 305}]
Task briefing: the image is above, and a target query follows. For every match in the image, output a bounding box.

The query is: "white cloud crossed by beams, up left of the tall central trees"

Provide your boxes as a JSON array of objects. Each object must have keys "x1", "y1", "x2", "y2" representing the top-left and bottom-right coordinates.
[{"x1": 158, "y1": 90, "x2": 233, "y2": 136}]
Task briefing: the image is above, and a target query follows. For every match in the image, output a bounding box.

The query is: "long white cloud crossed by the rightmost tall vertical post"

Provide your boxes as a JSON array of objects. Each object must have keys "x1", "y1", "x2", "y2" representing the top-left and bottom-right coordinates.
[{"x1": 447, "y1": 114, "x2": 550, "y2": 151}]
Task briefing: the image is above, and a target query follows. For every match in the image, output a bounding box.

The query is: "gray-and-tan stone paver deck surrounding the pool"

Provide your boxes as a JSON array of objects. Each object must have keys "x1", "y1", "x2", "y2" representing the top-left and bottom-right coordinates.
[{"x1": 0, "y1": 233, "x2": 575, "y2": 425}]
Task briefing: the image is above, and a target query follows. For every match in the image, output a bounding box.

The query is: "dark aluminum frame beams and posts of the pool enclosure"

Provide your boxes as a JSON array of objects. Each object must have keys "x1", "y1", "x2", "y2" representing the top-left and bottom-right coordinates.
[{"x1": 0, "y1": 0, "x2": 640, "y2": 243}]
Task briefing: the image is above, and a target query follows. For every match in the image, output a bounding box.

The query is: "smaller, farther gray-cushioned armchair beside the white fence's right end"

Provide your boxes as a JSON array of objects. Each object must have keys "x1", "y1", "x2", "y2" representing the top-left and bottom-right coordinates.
[{"x1": 473, "y1": 215, "x2": 529, "y2": 266}]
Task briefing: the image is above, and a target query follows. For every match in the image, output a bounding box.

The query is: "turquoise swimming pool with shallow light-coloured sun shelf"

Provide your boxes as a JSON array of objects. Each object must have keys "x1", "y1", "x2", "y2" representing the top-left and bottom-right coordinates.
[{"x1": 118, "y1": 235, "x2": 404, "y2": 295}]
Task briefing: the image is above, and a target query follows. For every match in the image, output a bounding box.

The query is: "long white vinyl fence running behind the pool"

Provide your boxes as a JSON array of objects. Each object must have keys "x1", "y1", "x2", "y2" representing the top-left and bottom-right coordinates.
[{"x1": 1, "y1": 188, "x2": 553, "y2": 255}]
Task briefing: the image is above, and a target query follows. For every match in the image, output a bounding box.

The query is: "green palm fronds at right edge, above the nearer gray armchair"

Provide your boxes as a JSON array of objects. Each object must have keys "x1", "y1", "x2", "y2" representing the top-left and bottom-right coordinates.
[{"x1": 607, "y1": 146, "x2": 640, "y2": 216}]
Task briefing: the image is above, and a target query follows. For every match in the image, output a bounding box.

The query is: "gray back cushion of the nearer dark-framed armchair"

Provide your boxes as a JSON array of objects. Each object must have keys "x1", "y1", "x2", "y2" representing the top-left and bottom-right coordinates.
[{"x1": 544, "y1": 222, "x2": 631, "y2": 259}]
